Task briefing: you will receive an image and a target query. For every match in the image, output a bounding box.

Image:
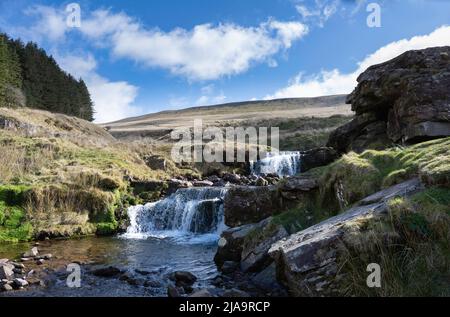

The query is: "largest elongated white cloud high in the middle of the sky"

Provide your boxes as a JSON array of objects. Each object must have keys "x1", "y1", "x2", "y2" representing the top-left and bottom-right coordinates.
[{"x1": 81, "y1": 10, "x2": 308, "y2": 80}]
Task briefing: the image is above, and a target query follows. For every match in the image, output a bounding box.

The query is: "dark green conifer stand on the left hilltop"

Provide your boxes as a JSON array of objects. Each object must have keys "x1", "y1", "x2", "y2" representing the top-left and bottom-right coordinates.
[{"x1": 0, "y1": 33, "x2": 94, "y2": 121}]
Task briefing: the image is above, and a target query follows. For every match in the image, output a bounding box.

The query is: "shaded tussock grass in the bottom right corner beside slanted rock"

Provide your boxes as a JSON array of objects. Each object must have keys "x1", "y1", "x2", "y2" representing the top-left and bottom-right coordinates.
[{"x1": 340, "y1": 187, "x2": 450, "y2": 296}]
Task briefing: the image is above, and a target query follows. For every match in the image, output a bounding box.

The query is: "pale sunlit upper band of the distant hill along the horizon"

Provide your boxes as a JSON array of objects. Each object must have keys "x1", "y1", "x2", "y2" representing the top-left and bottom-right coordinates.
[{"x1": 103, "y1": 95, "x2": 352, "y2": 138}]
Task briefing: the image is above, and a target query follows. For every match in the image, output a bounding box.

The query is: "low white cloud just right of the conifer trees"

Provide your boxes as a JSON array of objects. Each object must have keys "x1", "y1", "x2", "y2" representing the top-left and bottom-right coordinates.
[{"x1": 56, "y1": 54, "x2": 142, "y2": 123}]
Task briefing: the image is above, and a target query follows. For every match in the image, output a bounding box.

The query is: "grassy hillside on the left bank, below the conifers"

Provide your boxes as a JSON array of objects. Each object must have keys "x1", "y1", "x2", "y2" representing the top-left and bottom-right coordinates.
[{"x1": 0, "y1": 108, "x2": 194, "y2": 241}]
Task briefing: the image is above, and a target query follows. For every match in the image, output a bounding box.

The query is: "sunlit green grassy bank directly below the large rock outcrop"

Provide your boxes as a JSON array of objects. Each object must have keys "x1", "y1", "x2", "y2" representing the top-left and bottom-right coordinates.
[{"x1": 313, "y1": 138, "x2": 450, "y2": 209}]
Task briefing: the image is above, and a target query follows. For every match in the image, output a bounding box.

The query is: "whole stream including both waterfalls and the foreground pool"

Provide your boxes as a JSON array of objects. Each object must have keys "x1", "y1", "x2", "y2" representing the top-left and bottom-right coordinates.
[{"x1": 0, "y1": 152, "x2": 300, "y2": 297}]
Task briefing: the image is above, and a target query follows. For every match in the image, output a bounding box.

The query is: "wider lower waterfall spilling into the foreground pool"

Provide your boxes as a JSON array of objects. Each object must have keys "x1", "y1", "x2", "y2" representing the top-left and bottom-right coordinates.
[{"x1": 124, "y1": 187, "x2": 227, "y2": 240}]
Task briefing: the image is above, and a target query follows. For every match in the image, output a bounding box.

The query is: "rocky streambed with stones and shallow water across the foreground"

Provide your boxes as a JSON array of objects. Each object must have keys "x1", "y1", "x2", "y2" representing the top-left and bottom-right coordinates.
[{"x1": 0, "y1": 237, "x2": 284, "y2": 297}]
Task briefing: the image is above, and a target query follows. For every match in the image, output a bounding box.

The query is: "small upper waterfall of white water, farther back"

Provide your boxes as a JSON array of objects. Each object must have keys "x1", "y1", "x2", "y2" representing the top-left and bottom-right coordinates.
[{"x1": 250, "y1": 152, "x2": 301, "y2": 177}]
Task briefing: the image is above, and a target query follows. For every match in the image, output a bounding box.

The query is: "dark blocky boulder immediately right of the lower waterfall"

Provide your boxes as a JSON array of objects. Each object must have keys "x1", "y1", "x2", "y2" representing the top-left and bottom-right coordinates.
[{"x1": 224, "y1": 186, "x2": 284, "y2": 227}]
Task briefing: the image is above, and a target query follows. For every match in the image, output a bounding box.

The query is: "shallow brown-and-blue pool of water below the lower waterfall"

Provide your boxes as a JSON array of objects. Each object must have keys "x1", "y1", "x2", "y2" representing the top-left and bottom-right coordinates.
[{"x1": 0, "y1": 237, "x2": 217, "y2": 296}]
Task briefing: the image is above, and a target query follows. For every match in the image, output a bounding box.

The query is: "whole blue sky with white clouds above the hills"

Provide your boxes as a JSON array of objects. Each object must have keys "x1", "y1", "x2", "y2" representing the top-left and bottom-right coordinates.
[{"x1": 0, "y1": 0, "x2": 450, "y2": 122}]
